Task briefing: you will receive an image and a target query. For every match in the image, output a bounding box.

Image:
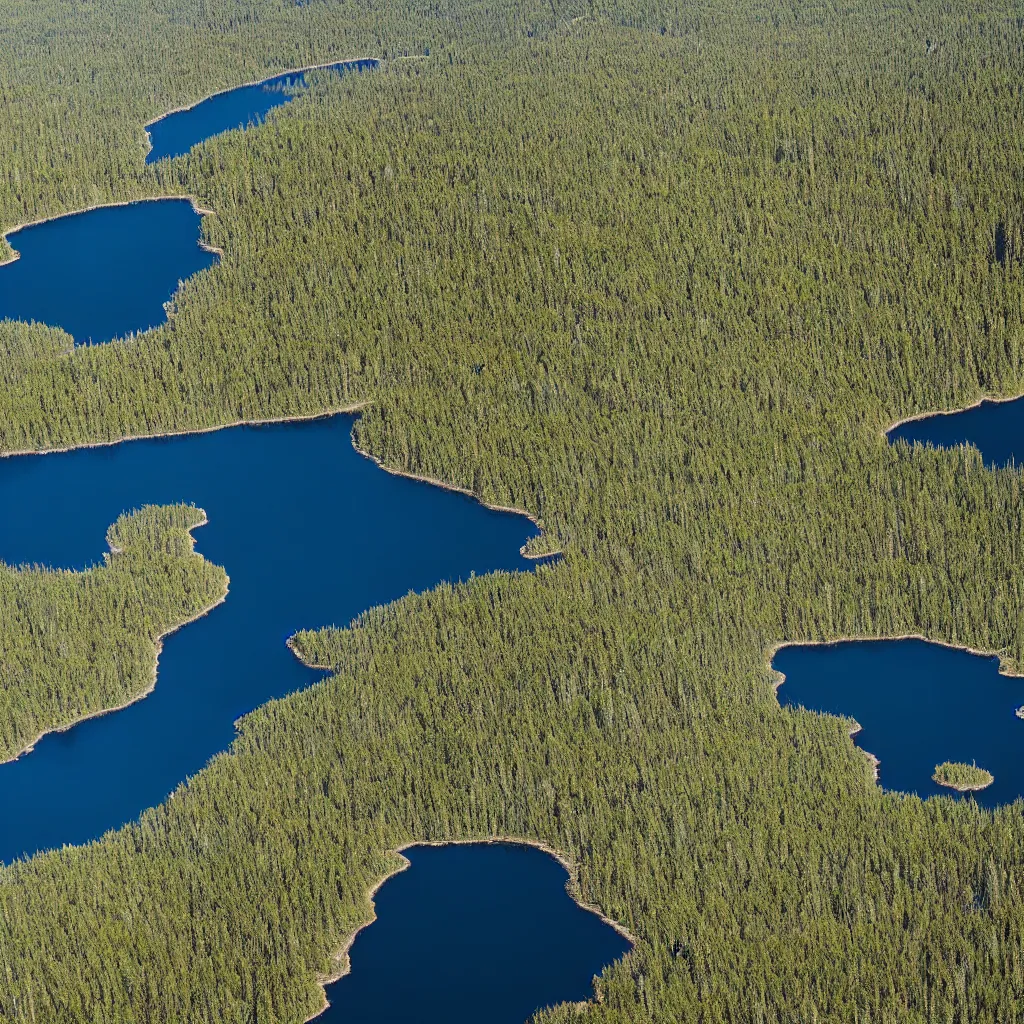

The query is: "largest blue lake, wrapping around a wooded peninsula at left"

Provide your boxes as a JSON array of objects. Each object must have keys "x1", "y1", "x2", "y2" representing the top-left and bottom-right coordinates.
[{"x1": 0, "y1": 415, "x2": 537, "y2": 861}]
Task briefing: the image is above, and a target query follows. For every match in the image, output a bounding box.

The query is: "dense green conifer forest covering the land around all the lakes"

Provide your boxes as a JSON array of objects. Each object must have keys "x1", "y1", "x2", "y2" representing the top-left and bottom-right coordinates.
[{"x1": 0, "y1": 0, "x2": 1024, "y2": 1024}]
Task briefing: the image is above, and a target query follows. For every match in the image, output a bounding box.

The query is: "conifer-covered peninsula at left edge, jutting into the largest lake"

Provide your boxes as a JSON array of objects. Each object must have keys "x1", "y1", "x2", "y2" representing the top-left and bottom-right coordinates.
[{"x1": 0, "y1": 505, "x2": 227, "y2": 759}]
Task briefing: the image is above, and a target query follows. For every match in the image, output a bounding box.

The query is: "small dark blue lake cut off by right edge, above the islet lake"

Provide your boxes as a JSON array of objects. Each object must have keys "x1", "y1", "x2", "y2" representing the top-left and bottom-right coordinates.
[{"x1": 888, "y1": 398, "x2": 1024, "y2": 466}]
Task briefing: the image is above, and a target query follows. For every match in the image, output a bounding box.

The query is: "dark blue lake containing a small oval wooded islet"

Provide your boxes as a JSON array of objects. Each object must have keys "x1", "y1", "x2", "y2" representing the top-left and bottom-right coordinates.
[{"x1": 772, "y1": 640, "x2": 1024, "y2": 807}]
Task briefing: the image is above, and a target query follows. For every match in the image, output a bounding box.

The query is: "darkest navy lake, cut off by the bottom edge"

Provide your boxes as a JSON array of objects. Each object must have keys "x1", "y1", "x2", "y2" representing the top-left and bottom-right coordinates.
[{"x1": 316, "y1": 843, "x2": 630, "y2": 1024}]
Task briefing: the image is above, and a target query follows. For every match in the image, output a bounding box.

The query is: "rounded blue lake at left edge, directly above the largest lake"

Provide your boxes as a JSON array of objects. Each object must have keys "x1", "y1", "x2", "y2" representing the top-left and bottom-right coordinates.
[{"x1": 0, "y1": 199, "x2": 217, "y2": 345}]
